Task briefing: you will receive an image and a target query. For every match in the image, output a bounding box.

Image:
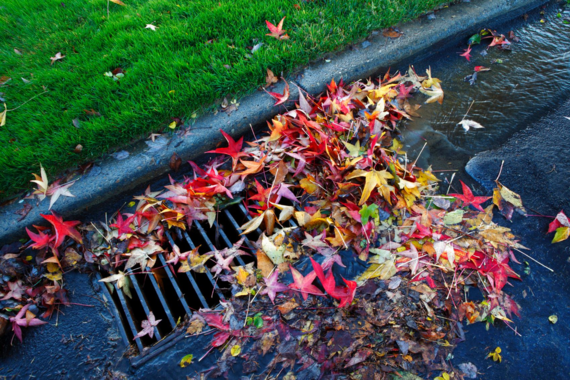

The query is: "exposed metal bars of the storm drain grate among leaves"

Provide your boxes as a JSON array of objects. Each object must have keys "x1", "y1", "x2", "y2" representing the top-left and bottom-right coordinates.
[{"x1": 97, "y1": 204, "x2": 261, "y2": 367}]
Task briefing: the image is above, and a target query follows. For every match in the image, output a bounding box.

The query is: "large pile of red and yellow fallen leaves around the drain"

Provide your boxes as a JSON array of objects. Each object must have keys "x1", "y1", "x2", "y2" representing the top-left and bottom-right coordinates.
[{"x1": 2, "y1": 68, "x2": 524, "y2": 378}]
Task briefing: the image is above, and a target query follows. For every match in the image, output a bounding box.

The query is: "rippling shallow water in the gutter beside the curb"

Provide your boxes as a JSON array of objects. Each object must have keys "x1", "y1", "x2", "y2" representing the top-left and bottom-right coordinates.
[{"x1": 400, "y1": 4, "x2": 570, "y2": 164}]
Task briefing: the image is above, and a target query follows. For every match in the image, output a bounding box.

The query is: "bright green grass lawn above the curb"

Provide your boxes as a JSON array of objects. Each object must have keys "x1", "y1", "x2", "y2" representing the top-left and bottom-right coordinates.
[{"x1": 0, "y1": 0, "x2": 444, "y2": 198}]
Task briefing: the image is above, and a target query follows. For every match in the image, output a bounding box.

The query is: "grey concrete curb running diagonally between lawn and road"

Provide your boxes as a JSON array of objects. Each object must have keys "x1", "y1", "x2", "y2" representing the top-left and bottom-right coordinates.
[{"x1": 0, "y1": 0, "x2": 547, "y2": 246}]
